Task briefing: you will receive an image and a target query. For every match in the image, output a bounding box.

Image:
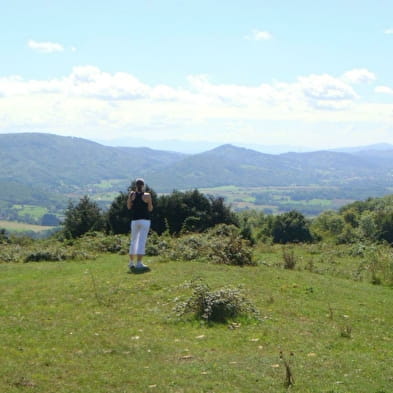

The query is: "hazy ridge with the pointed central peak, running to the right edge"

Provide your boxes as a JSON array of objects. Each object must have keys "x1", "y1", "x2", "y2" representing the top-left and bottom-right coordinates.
[{"x1": 148, "y1": 145, "x2": 393, "y2": 190}]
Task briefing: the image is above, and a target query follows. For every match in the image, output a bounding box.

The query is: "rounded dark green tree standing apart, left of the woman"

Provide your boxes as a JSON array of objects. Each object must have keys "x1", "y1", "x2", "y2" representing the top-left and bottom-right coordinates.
[{"x1": 63, "y1": 196, "x2": 105, "y2": 238}]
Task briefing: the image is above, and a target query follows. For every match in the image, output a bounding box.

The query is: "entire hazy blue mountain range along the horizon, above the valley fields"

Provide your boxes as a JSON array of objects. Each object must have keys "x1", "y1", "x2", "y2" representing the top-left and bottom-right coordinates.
[{"x1": 0, "y1": 133, "x2": 393, "y2": 192}]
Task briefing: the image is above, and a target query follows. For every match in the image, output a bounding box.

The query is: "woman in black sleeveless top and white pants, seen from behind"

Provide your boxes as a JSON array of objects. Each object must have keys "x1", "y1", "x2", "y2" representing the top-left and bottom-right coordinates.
[{"x1": 127, "y1": 178, "x2": 153, "y2": 272}]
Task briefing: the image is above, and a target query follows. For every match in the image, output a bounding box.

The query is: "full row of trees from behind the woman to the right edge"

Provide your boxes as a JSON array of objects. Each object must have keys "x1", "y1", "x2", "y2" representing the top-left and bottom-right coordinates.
[{"x1": 57, "y1": 184, "x2": 393, "y2": 244}]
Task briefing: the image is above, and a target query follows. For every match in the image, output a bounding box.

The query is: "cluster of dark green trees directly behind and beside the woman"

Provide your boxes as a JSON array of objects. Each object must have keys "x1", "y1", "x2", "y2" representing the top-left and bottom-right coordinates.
[{"x1": 62, "y1": 184, "x2": 237, "y2": 238}]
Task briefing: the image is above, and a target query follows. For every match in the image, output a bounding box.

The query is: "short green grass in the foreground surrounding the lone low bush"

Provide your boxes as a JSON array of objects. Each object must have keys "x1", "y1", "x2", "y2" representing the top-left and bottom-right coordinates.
[{"x1": 0, "y1": 253, "x2": 393, "y2": 393}]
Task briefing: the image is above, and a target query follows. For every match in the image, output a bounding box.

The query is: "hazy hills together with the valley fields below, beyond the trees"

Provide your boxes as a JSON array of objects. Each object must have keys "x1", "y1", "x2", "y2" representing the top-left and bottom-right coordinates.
[{"x1": 0, "y1": 133, "x2": 393, "y2": 218}]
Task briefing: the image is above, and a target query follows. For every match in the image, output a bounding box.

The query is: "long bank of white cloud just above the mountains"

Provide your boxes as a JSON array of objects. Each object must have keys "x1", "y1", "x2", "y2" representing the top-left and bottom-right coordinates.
[{"x1": 0, "y1": 66, "x2": 393, "y2": 147}]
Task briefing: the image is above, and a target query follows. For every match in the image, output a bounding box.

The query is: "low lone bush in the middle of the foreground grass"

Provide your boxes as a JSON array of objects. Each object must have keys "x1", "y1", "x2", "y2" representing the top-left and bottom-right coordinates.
[{"x1": 175, "y1": 280, "x2": 258, "y2": 323}]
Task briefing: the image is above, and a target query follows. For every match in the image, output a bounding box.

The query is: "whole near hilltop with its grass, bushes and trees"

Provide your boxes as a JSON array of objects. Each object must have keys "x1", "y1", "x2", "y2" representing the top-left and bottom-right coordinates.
[{"x1": 0, "y1": 190, "x2": 393, "y2": 393}]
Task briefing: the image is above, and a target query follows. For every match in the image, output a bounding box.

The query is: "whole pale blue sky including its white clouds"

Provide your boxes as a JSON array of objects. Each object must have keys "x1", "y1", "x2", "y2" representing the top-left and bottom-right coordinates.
[{"x1": 0, "y1": 0, "x2": 393, "y2": 148}]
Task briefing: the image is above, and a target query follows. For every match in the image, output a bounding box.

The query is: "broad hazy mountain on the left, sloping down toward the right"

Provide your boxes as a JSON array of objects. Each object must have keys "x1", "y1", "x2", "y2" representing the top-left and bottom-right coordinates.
[{"x1": 0, "y1": 133, "x2": 184, "y2": 191}]
